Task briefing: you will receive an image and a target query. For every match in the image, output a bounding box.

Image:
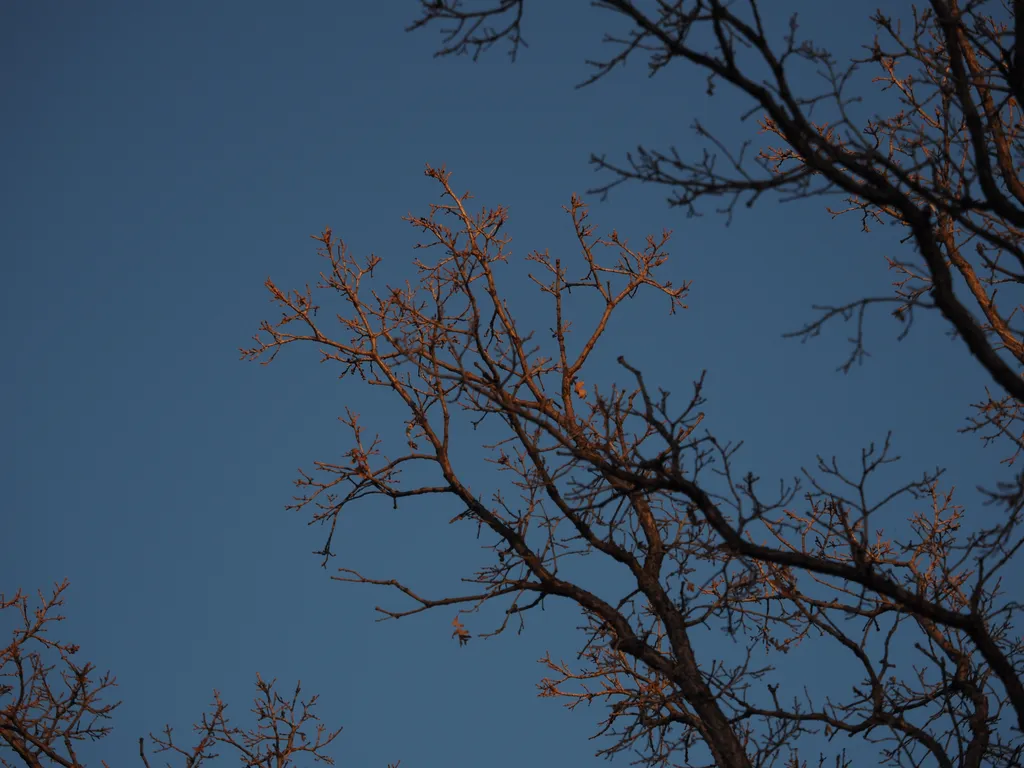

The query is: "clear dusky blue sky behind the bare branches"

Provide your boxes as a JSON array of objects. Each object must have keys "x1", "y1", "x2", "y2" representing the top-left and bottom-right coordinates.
[{"x1": 0, "y1": 0, "x2": 1015, "y2": 768}]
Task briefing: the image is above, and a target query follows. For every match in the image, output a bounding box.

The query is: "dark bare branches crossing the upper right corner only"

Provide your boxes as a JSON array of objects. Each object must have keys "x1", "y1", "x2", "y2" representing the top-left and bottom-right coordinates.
[{"x1": 410, "y1": 0, "x2": 1024, "y2": 481}]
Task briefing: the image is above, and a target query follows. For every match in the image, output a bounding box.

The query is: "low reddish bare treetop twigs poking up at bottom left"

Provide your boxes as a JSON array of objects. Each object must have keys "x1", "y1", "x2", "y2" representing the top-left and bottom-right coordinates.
[{"x1": 0, "y1": 581, "x2": 368, "y2": 768}]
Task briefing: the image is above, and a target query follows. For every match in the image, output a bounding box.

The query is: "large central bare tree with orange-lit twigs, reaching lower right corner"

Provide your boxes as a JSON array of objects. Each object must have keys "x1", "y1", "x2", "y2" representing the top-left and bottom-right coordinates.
[{"x1": 243, "y1": 153, "x2": 1024, "y2": 767}]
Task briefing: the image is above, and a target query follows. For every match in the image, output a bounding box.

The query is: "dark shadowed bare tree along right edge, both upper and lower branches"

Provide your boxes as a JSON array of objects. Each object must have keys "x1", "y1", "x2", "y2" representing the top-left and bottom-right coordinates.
[{"x1": 391, "y1": 0, "x2": 1024, "y2": 765}]
